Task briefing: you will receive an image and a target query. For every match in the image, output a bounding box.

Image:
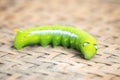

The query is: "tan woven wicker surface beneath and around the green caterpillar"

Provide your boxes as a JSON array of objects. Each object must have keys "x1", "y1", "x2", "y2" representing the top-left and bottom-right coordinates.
[{"x1": 0, "y1": 0, "x2": 120, "y2": 80}]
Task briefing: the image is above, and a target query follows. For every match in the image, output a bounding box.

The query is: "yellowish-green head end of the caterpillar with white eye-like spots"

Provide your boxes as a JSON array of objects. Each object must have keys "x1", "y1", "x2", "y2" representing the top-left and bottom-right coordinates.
[{"x1": 81, "y1": 41, "x2": 98, "y2": 60}]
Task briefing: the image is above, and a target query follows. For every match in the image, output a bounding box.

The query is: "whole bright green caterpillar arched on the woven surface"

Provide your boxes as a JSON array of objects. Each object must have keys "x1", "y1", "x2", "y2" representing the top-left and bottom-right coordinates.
[{"x1": 14, "y1": 26, "x2": 97, "y2": 59}]
